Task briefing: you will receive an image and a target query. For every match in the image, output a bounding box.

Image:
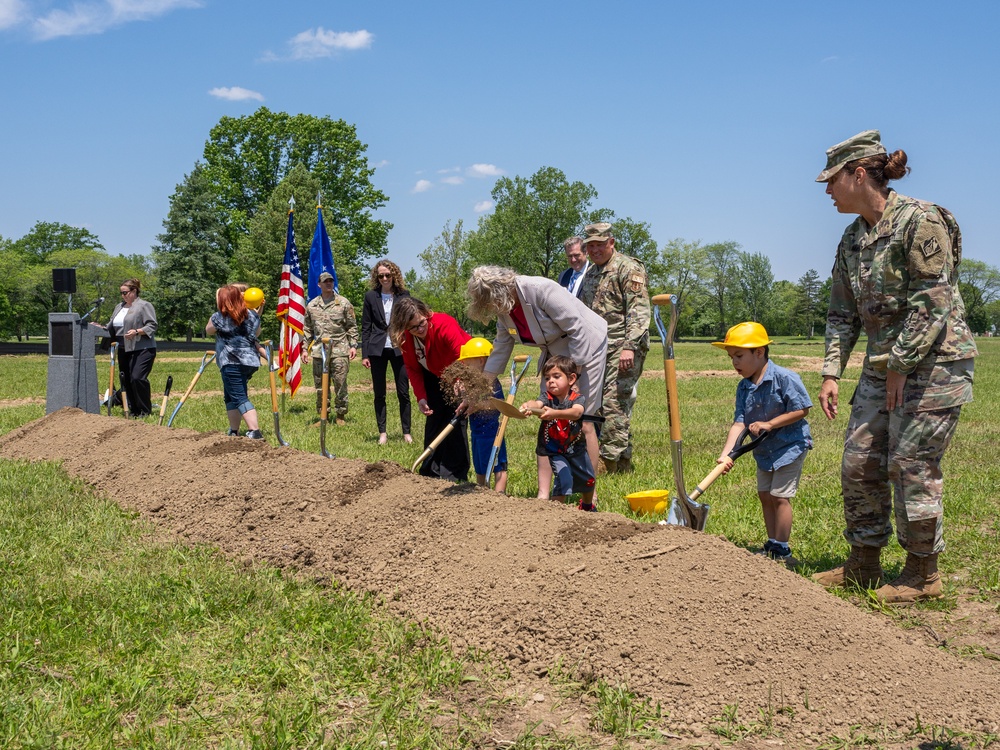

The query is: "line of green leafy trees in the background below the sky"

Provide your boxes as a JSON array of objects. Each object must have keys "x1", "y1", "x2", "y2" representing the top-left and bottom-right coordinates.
[{"x1": 0, "y1": 119, "x2": 1000, "y2": 340}]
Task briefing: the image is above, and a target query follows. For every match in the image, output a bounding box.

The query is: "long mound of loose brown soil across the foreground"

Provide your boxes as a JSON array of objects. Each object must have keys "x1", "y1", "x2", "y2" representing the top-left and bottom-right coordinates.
[{"x1": 0, "y1": 409, "x2": 1000, "y2": 747}]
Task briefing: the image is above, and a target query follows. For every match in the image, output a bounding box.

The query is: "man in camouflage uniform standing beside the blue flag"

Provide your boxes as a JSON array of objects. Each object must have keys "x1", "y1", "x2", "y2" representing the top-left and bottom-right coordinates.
[{"x1": 302, "y1": 271, "x2": 358, "y2": 425}]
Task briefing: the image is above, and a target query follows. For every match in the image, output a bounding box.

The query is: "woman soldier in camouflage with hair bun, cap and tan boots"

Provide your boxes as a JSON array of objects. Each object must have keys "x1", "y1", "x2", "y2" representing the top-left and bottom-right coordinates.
[{"x1": 814, "y1": 130, "x2": 977, "y2": 603}]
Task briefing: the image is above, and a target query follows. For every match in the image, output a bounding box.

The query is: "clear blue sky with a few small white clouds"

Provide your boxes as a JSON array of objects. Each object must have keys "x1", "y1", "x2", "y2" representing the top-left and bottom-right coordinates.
[{"x1": 0, "y1": 0, "x2": 1000, "y2": 281}]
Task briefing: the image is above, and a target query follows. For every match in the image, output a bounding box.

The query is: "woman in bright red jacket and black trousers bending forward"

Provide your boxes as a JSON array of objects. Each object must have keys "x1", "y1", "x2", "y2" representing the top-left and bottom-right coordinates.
[{"x1": 389, "y1": 297, "x2": 472, "y2": 482}]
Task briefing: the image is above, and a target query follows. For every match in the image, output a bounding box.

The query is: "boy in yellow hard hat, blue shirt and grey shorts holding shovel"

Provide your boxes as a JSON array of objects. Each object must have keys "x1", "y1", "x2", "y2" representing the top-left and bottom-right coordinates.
[{"x1": 712, "y1": 321, "x2": 812, "y2": 567}]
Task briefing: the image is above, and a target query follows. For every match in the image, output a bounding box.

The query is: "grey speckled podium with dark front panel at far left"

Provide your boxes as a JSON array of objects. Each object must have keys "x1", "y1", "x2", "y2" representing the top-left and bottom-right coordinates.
[{"x1": 45, "y1": 312, "x2": 107, "y2": 414}]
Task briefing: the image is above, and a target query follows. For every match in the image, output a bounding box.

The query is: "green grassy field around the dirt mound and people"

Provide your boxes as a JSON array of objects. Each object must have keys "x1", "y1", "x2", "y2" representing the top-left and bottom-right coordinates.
[{"x1": 0, "y1": 339, "x2": 1000, "y2": 748}]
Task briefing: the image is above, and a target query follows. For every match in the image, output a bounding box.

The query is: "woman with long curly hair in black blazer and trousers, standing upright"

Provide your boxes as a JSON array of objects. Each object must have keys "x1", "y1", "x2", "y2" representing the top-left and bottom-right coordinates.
[{"x1": 361, "y1": 260, "x2": 413, "y2": 445}]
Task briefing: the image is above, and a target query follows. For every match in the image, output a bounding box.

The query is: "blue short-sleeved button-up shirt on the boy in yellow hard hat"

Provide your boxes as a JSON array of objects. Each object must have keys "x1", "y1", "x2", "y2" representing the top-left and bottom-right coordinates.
[{"x1": 733, "y1": 361, "x2": 812, "y2": 471}]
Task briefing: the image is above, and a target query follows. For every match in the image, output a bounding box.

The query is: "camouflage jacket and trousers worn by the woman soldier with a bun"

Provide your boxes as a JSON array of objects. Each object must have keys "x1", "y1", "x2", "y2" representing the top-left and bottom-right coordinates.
[{"x1": 823, "y1": 191, "x2": 978, "y2": 555}]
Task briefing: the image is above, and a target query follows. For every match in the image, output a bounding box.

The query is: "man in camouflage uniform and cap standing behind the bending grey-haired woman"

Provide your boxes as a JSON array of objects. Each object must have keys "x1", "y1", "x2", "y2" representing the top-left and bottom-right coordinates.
[{"x1": 580, "y1": 222, "x2": 650, "y2": 473}]
